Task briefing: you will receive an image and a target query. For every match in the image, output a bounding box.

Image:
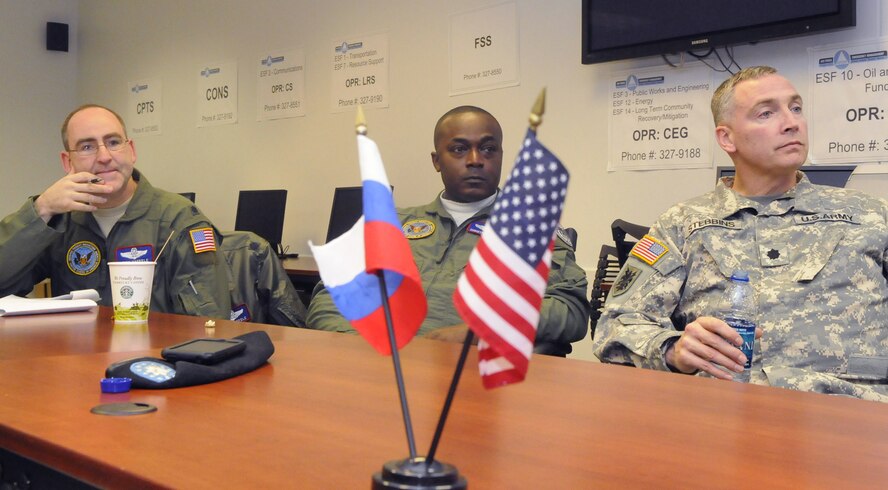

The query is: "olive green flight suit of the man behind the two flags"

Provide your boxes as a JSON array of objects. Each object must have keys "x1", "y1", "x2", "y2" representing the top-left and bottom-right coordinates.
[{"x1": 307, "y1": 198, "x2": 589, "y2": 354}]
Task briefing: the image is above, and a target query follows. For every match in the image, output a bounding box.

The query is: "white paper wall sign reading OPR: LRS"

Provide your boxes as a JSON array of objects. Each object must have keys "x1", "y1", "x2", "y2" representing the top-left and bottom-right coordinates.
[{"x1": 330, "y1": 34, "x2": 389, "y2": 112}]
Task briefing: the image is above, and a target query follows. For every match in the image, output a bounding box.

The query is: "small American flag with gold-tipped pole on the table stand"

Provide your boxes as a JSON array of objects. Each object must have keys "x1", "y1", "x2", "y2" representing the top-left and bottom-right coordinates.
[{"x1": 453, "y1": 130, "x2": 569, "y2": 388}]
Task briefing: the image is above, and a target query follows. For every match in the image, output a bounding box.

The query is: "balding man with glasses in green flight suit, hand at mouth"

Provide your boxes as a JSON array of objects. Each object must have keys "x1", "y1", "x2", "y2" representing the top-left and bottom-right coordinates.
[{"x1": 0, "y1": 105, "x2": 231, "y2": 319}]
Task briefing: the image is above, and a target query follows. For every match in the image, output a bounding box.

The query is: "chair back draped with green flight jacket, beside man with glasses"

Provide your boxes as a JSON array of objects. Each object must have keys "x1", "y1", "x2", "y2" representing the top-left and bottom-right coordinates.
[{"x1": 221, "y1": 231, "x2": 306, "y2": 327}]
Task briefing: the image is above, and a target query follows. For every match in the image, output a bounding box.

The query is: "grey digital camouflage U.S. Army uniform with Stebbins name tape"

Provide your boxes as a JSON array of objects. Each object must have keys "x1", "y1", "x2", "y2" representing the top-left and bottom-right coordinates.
[{"x1": 594, "y1": 173, "x2": 888, "y2": 401}]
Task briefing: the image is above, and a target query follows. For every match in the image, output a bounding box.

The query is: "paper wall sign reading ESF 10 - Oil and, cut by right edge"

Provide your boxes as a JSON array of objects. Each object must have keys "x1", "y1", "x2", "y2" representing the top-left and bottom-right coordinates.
[{"x1": 804, "y1": 42, "x2": 888, "y2": 163}]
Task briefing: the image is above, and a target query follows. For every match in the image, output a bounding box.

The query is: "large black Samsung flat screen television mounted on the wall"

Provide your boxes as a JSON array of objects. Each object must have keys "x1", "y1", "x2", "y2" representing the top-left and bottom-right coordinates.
[{"x1": 582, "y1": 0, "x2": 856, "y2": 65}]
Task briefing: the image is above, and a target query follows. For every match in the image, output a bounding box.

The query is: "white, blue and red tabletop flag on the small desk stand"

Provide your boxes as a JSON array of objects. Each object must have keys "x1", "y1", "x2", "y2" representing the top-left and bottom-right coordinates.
[{"x1": 309, "y1": 135, "x2": 428, "y2": 355}]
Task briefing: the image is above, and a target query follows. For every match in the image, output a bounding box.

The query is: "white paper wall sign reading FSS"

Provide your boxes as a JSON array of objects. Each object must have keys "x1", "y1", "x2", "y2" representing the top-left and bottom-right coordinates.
[{"x1": 450, "y1": 2, "x2": 519, "y2": 95}]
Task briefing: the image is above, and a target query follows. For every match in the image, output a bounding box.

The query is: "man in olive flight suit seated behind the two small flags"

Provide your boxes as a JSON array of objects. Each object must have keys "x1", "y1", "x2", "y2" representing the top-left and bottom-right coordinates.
[{"x1": 307, "y1": 106, "x2": 589, "y2": 355}]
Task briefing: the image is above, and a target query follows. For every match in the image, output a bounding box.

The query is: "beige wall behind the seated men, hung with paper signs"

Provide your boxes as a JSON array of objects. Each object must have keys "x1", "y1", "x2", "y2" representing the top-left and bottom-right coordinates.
[{"x1": 0, "y1": 0, "x2": 888, "y2": 357}]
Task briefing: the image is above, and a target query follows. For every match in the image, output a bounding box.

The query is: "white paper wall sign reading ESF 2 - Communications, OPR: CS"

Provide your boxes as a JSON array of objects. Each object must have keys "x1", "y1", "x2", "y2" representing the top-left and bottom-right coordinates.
[{"x1": 256, "y1": 49, "x2": 305, "y2": 121}]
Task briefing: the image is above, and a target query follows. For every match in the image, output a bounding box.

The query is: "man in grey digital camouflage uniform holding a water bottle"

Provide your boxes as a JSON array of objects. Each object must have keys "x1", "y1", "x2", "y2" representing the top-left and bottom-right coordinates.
[{"x1": 594, "y1": 67, "x2": 888, "y2": 401}]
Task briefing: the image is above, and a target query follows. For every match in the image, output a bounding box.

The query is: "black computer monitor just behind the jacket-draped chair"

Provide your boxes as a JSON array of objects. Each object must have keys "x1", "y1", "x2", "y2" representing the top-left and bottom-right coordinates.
[{"x1": 234, "y1": 189, "x2": 287, "y2": 254}]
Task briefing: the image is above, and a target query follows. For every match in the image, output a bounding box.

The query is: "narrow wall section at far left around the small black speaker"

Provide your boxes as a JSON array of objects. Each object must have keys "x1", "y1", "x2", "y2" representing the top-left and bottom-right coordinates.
[{"x1": 0, "y1": 0, "x2": 77, "y2": 217}]
